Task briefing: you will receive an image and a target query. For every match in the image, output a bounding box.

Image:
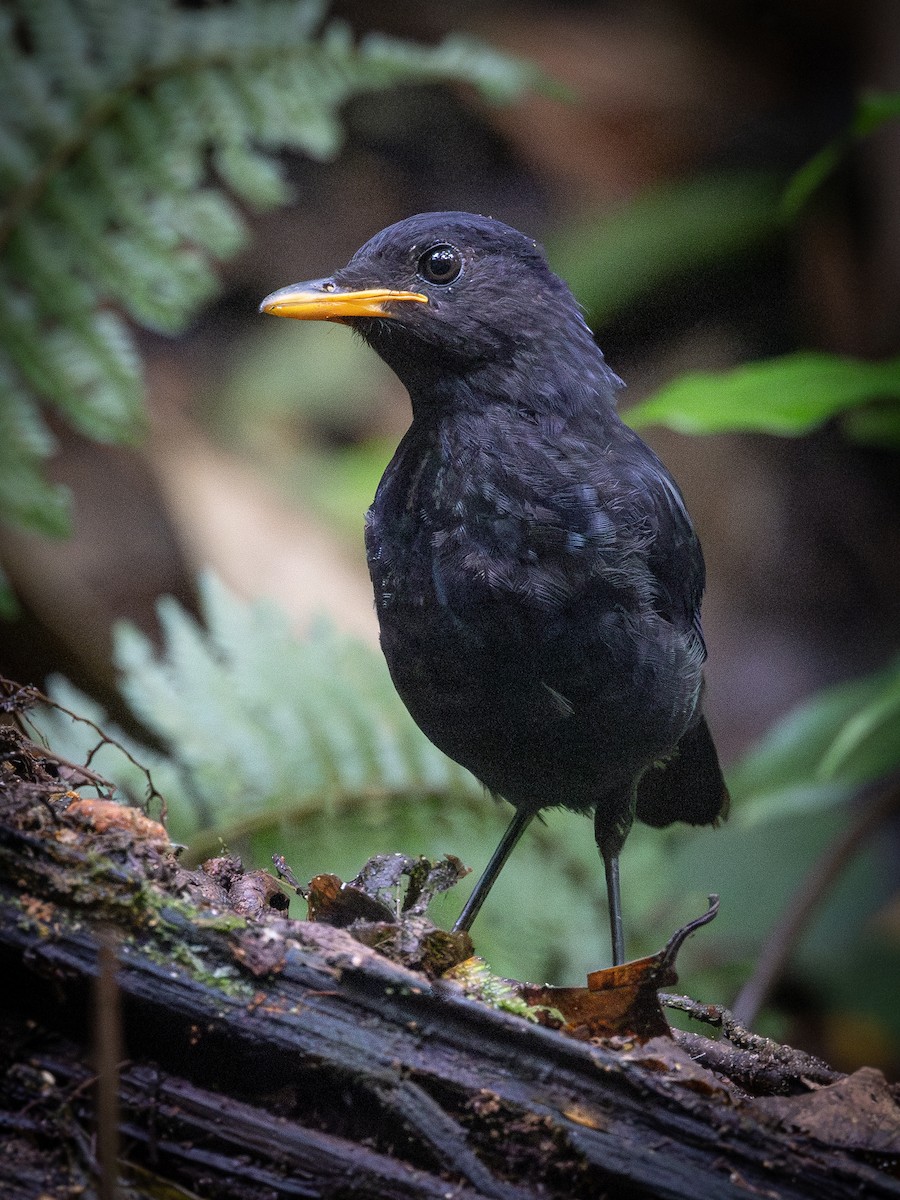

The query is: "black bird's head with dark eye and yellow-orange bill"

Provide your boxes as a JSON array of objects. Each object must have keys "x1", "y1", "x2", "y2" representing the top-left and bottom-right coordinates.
[{"x1": 260, "y1": 212, "x2": 619, "y2": 417}]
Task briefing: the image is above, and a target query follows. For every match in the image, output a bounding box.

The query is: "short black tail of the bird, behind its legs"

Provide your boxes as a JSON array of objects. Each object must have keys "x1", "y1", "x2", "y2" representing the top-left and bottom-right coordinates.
[{"x1": 636, "y1": 716, "x2": 728, "y2": 828}]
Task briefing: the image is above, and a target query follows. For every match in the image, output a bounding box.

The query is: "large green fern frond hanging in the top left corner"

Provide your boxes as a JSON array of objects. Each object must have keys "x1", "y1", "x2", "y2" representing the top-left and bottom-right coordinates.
[{"x1": 0, "y1": 0, "x2": 534, "y2": 535}]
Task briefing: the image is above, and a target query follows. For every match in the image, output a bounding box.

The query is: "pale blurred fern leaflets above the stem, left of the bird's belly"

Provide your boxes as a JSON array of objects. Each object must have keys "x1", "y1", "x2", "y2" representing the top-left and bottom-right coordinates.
[{"x1": 108, "y1": 578, "x2": 476, "y2": 836}]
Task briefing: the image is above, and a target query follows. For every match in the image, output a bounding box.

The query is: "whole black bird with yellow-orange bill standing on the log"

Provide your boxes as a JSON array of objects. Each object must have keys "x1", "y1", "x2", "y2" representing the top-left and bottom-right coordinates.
[{"x1": 260, "y1": 212, "x2": 727, "y2": 964}]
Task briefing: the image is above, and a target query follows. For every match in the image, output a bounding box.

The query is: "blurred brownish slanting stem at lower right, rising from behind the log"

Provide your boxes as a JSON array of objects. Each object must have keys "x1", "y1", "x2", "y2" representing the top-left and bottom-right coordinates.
[{"x1": 733, "y1": 782, "x2": 900, "y2": 1025}]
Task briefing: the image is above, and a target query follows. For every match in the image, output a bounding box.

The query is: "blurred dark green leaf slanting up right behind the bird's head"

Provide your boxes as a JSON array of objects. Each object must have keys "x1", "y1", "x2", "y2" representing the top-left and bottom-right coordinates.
[{"x1": 546, "y1": 172, "x2": 781, "y2": 324}]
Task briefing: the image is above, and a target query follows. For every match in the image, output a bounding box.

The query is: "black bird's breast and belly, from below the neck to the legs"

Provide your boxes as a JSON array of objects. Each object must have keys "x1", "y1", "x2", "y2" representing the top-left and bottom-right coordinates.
[{"x1": 366, "y1": 417, "x2": 700, "y2": 806}]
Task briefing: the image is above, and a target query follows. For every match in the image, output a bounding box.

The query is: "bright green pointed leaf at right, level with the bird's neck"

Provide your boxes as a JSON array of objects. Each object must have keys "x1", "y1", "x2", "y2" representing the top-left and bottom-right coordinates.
[{"x1": 624, "y1": 353, "x2": 900, "y2": 436}]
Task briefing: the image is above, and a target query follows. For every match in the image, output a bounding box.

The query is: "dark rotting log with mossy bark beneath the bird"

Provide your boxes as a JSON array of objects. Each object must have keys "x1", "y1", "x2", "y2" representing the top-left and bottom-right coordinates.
[{"x1": 0, "y1": 753, "x2": 900, "y2": 1200}]
